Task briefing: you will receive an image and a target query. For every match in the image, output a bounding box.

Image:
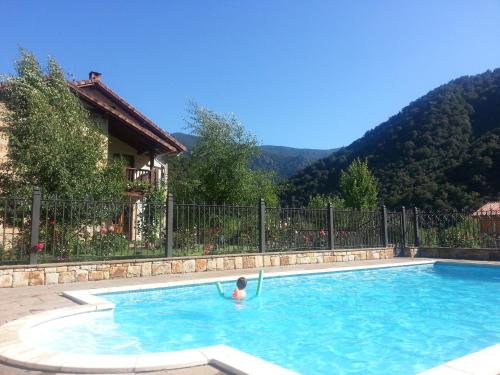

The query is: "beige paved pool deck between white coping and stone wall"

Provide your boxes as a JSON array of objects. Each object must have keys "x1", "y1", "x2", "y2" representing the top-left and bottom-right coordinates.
[{"x1": 0, "y1": 258, "x2": 500, "y2": 375}]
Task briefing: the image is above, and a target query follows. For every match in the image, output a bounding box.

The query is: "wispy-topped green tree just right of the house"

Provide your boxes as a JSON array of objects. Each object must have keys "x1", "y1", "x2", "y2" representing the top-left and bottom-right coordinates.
[{"x1": 169, "y1": 104, "x2": 278, "y2": 205}]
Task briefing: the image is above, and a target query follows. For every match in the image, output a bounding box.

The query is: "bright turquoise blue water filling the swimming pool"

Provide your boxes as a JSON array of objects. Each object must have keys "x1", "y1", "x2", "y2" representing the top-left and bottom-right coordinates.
[{"x1": 28, "y1": 263, "x2": 500, "y2": 374}]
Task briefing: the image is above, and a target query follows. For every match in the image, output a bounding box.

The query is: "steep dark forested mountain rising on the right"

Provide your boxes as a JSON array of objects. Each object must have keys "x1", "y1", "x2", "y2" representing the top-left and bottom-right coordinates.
[{"x1": 283, "y1": 69, "x2": 500, "y2": 209}]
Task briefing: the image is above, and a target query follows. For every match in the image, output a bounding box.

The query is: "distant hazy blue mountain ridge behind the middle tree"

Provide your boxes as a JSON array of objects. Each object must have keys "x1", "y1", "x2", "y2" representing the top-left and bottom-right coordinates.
[{"x1": 172, "y1": 133, "x2": 334, "y2": 178}]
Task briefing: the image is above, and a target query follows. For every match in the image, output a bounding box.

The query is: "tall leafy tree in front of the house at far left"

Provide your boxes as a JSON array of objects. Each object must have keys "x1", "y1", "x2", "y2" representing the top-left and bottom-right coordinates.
[{"x1": 1, "y1": 50, "x2": 126, "y2": 203}]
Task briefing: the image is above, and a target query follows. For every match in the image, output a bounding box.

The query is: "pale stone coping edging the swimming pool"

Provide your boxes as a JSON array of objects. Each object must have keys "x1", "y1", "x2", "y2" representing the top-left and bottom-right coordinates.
[{"x1": 0, "y1": 260, "x2": 500, "y2": 375}]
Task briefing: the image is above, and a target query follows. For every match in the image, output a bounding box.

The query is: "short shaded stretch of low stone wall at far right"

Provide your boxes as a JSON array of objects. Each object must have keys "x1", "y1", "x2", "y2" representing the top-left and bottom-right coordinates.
[{"x1": 405, "y1": 247, "x2": 500, "y2": 261}]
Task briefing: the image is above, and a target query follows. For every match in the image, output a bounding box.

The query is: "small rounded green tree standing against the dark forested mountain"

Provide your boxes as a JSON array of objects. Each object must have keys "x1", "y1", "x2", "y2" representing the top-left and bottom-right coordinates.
[{"x1": 340, "y1": 159, "x2": 378, "y2": 209}]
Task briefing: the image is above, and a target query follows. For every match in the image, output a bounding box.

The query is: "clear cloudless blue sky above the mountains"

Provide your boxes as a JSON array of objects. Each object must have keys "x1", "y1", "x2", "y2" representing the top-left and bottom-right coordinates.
[{"x1": 0, "y1": 0, "x2": 500, "y2": 149}]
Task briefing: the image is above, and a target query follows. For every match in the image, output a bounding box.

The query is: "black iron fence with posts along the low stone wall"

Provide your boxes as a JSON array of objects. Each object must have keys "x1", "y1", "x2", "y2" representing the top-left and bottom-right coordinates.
[{"x1": 0, "y1": 189, "x2": 500, "y2": 264}]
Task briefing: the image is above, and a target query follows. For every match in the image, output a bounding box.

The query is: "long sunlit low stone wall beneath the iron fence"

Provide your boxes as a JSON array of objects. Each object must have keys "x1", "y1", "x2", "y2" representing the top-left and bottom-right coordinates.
[{"x1": 0, "y1": 247, "x2": 394, "y2": 288}]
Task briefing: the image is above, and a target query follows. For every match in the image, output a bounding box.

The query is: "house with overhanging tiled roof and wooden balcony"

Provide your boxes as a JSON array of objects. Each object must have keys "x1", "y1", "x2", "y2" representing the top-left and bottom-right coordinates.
[{"x1": 0, "y1": 71, "x2": 186, "y2": 238}]
